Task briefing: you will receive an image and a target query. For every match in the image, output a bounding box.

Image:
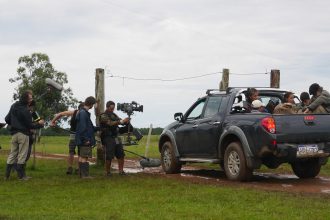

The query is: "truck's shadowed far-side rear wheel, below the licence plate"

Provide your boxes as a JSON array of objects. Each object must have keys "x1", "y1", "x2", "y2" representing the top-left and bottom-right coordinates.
[{"x1": 291, "y1": 158, "x2": 321, "y2": 179}]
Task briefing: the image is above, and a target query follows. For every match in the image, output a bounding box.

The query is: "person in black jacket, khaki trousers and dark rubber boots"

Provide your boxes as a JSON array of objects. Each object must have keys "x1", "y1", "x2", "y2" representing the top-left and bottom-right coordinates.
[{"x1": 5, "y1": 90, "x2": 44, "y2": 180}]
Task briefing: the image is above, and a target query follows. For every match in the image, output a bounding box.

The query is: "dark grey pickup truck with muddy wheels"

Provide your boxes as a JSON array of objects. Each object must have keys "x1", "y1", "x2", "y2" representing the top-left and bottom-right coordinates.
[{"x1": 159, "y1": 88, "x2": 330, "y2": 181}]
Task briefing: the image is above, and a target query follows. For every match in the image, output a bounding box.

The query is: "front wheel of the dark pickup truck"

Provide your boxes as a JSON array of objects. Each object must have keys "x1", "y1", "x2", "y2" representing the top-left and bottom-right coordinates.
[{"x1": 161, "y1": 141, "x2": 181, "y2": 174}]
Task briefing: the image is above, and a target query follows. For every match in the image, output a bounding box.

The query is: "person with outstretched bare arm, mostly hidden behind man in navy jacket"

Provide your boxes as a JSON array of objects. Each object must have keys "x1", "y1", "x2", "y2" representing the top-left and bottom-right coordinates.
[{"x1": 50, "y1": 102, "x2": 84, "y2": 175}]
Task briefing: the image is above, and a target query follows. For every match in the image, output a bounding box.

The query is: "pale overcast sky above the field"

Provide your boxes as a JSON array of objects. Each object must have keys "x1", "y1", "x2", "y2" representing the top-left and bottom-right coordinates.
[{"x1": 0, "y1": 0, "x2": 330, "y2": 127}]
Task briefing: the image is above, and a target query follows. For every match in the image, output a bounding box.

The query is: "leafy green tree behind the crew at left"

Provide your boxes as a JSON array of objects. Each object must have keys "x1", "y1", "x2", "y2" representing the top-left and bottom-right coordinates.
[{"x1": 9, "y1": 53, "x2": 77, "y2": 121}]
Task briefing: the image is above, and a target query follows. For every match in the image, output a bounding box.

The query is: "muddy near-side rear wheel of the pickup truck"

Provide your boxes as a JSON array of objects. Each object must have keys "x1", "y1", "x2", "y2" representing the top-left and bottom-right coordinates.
[{"x1": 224, "y1": 142, "x2": 253, "y2": 181}]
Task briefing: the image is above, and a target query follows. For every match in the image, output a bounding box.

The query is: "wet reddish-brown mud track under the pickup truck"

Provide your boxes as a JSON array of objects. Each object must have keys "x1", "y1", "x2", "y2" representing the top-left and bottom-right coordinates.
[{"x1": 17, "y1": 153, "x2": 330, "y2": 195}]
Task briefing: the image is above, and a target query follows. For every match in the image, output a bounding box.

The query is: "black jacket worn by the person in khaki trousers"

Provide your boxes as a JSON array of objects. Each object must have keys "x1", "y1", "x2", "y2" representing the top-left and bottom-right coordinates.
[{"x1": 5, "y1": 101, "x2": 43, "y2": 135}]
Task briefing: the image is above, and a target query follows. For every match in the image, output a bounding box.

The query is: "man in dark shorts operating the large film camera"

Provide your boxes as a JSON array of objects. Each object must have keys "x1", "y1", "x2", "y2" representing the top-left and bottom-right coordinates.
[{"x1": 100, "y1": 101, "x2": 133, "y2": 176}]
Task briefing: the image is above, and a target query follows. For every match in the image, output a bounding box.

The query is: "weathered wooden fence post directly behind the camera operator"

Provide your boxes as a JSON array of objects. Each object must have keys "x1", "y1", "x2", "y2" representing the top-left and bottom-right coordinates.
[{"x1": 95, "y1": 68, "x2": 105, "y2": 165}]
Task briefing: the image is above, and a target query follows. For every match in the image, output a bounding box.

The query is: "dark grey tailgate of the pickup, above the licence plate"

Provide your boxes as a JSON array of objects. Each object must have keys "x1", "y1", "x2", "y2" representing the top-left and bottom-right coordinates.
[{"x1": 273, "y1": 114, "x2": 330, "y2": 144}]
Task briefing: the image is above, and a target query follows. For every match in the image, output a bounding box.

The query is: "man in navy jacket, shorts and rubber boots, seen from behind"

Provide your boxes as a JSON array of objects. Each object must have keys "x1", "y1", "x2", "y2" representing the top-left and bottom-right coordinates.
[{"x1": 75, "y1": 96, "x2": 98, "y2": 178}]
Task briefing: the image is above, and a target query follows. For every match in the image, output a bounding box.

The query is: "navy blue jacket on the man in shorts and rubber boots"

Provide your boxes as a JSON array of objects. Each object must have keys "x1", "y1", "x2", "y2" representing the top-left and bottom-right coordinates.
[{"x1": 76, "y1": 108, "x2": 97, "y2": 146}]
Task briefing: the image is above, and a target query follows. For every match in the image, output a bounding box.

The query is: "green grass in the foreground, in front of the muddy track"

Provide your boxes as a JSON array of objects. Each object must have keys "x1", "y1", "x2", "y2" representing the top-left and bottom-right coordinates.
[{"x1": 0, "y1": 155, "x2": 330, "y2": 220}]
